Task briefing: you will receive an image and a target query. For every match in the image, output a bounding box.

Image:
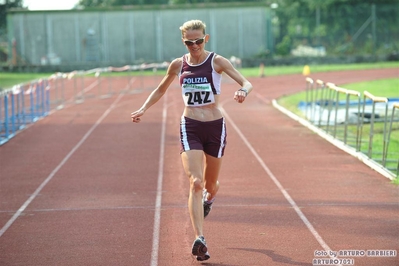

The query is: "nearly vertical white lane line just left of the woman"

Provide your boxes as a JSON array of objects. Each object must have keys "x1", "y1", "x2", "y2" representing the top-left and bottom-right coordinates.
[{"x1": 151, "y1": 93, "x2": 168, "y2": 266}]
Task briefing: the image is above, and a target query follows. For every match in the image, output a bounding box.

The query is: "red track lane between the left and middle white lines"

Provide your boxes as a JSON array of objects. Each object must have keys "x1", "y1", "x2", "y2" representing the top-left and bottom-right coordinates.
[{"x1": 0, "y1": 81, "x2": 166, "y2": 265}]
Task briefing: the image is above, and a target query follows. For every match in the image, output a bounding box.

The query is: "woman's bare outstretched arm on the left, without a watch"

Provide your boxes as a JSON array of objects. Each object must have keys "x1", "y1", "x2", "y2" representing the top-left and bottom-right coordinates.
[{"x1": 130, "y1": 58, "x2": 181, "y2": 123}]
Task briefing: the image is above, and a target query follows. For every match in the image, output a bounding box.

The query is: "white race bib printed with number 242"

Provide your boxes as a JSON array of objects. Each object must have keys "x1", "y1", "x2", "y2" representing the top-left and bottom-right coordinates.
[{"x1": 182, "y1": 83, "x2": 215, "y2": 106}]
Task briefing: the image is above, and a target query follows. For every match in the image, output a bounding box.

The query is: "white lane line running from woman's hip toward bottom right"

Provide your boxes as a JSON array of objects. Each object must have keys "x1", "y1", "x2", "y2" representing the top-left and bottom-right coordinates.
[{"x1": 221, "y1": 107, "x2": 331, "y2": 254}]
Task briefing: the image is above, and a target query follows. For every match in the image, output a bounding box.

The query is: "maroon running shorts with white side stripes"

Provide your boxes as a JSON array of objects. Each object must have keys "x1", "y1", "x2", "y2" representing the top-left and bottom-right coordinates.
[{"x1": 180, "y1": 116, "x2": 227, "y2": 158}]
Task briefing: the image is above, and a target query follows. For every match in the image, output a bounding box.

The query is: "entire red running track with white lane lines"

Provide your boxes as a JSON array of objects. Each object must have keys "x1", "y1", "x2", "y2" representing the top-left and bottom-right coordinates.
[{"x1": 0, "y1": 69, "x2": 399, "y2": 266}]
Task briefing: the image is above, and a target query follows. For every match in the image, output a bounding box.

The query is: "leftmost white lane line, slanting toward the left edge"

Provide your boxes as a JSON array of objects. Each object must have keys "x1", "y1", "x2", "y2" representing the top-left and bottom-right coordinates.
[{"x1": 0, "y1": 94, "x2": 123, "y2": 237}]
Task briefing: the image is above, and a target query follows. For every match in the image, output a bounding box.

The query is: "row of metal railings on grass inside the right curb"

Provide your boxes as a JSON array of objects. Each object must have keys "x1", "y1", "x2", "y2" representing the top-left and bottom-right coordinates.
[{"x1": 302, "y1": 77, "x2": 399, "y2": 176}]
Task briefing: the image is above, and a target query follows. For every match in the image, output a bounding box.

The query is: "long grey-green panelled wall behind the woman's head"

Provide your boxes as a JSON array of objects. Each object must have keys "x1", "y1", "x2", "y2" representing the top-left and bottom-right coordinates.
[{"x1": 8, "y1": 6, "x2": 272, "y2": 71}]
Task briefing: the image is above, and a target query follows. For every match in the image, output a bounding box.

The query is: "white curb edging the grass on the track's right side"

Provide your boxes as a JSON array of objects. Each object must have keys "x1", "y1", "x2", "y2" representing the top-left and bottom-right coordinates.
[{"x1": 272, "y1": 99, "x2": 396, "y2": 180}]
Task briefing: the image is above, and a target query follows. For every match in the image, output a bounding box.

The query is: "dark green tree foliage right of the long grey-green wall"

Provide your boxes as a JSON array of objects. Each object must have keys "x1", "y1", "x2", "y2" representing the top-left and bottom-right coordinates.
[{"x1": 274, "y1": 0, "x2": 399, "y2": 54}]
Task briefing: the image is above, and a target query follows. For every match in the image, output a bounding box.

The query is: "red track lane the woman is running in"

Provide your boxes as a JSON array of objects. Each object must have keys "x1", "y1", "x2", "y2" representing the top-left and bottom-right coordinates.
[{"x1": 155, "y1": 83, "x2": 324, "y2": 265}]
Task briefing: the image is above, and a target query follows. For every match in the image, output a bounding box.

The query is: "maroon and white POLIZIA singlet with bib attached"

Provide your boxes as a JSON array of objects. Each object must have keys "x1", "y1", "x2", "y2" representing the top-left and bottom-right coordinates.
[{"x1": 179, "y1": 52, "x2": 222, "y2": 106}]
